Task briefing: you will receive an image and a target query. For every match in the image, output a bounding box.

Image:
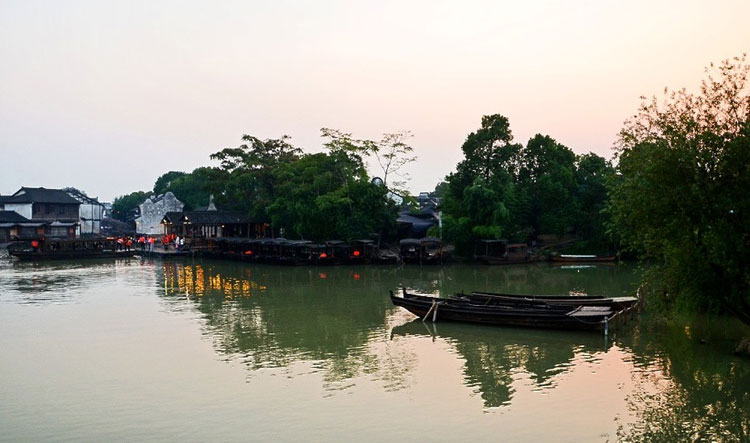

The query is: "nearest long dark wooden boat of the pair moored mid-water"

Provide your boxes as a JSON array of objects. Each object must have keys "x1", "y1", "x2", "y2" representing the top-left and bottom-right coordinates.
[{"x1": 391, "y1": 290, "x2": 616, "y2": 330}]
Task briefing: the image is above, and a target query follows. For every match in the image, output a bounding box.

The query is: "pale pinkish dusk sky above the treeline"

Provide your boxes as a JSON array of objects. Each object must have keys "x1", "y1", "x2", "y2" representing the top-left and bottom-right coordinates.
[{"x1": 0, "y1": 0, "x2": 750, "y2": 201}]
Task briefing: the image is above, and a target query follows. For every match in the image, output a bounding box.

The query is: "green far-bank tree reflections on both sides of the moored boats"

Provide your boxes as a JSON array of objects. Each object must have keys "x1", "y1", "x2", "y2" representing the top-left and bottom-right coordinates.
[{"x1": 160, "y1": 261, "x2": 644, "y2": 396}]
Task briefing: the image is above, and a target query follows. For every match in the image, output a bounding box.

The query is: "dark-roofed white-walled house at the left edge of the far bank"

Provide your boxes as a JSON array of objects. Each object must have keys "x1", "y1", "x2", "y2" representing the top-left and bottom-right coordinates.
[{"x1": 0, "y1": 187, "x2": 80, "y2": 238}]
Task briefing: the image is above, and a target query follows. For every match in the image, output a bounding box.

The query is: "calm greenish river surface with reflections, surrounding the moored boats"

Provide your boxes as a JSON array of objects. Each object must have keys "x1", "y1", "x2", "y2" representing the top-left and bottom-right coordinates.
[{"x1": 0, "y1": 252, "x2": 750, "y2": 442}]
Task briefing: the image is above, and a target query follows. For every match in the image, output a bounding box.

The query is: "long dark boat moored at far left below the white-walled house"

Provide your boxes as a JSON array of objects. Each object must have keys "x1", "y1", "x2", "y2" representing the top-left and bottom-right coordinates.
[{"x1": 8, "y1": 237, "x2": 137, "y2": 261}]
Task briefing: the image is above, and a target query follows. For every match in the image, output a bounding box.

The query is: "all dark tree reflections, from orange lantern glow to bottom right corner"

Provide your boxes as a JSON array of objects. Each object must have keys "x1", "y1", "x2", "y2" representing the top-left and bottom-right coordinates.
[{"x1": 147, "y1": 261, "x2": 750, "y2": 434}]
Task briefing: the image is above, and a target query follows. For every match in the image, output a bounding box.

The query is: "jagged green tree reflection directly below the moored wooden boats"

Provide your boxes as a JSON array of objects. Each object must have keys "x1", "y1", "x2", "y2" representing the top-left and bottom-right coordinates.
[{"x1": 393, "y1": 320, "x2": 605, "y2": 407}]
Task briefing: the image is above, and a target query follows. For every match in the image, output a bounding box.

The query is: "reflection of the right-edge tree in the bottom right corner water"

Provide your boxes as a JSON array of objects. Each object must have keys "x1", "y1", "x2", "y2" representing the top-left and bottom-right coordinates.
[{"x1": 618, "y1": 320, "x2": 750, "y2": 441}]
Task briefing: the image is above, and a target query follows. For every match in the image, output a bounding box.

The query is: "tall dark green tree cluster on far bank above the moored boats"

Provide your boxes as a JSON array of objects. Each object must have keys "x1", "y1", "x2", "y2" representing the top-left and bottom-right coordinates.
[{"x1": 444, "y1": 115, "x2": 613, "y2": 254}]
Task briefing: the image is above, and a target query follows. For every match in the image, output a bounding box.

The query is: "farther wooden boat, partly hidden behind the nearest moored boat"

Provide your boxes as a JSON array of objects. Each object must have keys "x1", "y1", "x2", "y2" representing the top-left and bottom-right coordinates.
[{"x1": 462, "y1": 291, "x2": 638, "y2": 310}]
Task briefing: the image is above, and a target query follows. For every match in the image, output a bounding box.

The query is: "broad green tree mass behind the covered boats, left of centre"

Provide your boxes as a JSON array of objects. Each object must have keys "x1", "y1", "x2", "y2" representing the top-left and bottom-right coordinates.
[{"x1": 212, "y1": 133, "x2": 395, "y2": 240}]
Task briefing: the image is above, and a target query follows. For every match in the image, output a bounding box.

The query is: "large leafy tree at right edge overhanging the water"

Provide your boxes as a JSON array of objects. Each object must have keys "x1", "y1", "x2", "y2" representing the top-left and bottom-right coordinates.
[{"x1": 608, "y1": 56, "x2": 750, "y2": 324}]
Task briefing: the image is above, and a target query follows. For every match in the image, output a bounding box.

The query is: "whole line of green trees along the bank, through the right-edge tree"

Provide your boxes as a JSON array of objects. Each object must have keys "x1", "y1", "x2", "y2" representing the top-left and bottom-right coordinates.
[{"x1": 108, "y1": 56, "x2": 750, "y2": 332}]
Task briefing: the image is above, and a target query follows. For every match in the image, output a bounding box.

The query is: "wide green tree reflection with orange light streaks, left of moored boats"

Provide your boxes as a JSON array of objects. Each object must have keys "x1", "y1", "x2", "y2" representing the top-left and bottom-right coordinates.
[{"x1": 159, "y1": 262, "x2": 413, "y2": 388}]
